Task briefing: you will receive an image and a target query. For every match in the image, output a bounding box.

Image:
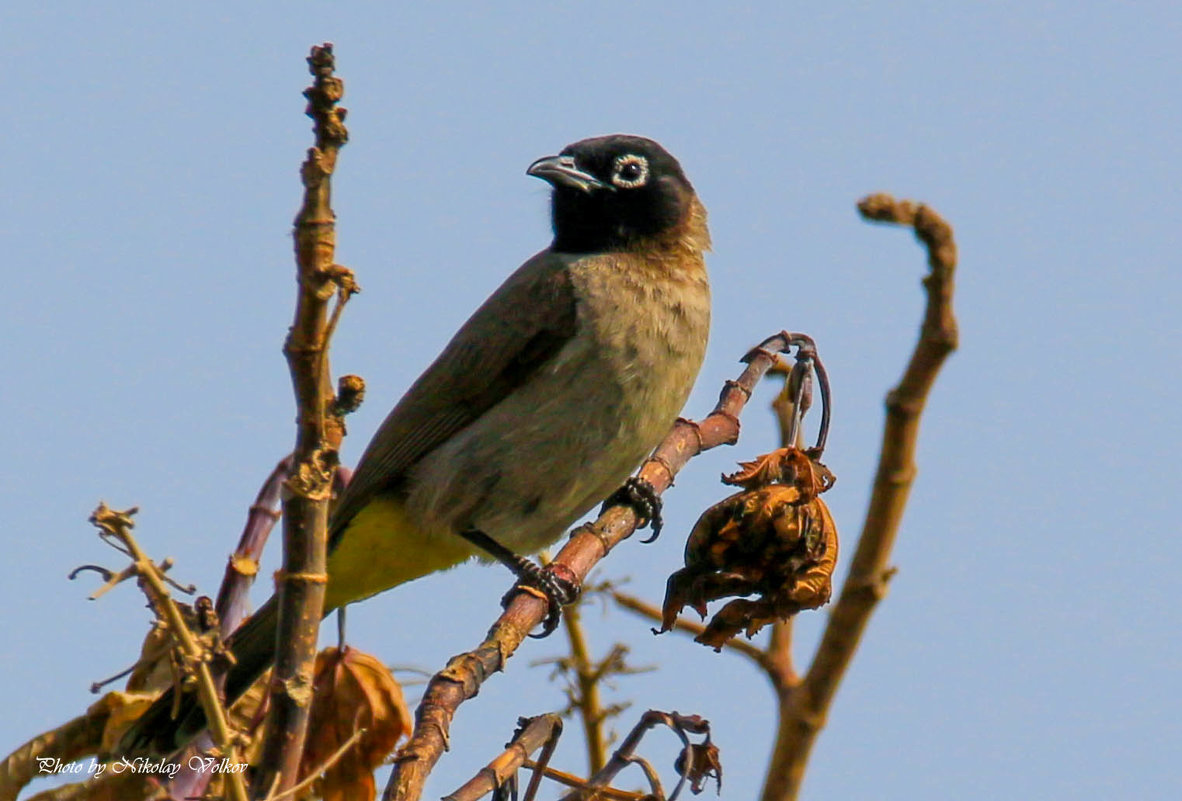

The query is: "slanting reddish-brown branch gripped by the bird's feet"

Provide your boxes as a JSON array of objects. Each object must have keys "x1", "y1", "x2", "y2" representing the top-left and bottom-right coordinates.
[{"x1": 383, "y1": 332, "x2": 812, "y2": 801}]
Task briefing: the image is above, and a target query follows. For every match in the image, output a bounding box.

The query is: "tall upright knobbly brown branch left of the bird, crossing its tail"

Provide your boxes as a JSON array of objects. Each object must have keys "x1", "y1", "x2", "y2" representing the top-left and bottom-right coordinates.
[{"x1": 261, "y1": 44, "x2": 357, "y2": 797}]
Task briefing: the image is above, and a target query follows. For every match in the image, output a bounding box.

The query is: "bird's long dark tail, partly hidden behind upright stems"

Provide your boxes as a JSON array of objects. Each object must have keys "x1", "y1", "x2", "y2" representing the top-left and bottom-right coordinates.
[{"x1": 118, "y1": 595, "x2": 279, "y2": 757}]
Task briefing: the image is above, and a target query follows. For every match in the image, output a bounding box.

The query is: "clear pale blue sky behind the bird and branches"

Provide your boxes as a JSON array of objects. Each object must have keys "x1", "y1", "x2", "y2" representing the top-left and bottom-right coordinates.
[{"x1": 0, "y1": 2, "x2": 1182, "y2": 799}]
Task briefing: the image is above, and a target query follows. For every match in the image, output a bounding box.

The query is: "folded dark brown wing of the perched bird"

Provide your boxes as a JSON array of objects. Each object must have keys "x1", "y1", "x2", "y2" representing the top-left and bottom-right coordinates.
[{"x1": 330, "y1": 250, "x2": 577, "y2": 542}]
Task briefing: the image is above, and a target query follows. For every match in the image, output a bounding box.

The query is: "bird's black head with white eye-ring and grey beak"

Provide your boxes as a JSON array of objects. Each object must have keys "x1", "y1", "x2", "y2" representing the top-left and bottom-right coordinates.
[{"x1": 526, "y1": 134, "x2": 704, "y2": 253}]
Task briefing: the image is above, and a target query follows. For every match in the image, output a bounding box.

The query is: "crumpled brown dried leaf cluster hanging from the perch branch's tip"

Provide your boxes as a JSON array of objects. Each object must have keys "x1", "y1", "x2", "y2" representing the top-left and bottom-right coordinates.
[{"x1": 661, "y1": 448, "x2": 838, "y2": 650}]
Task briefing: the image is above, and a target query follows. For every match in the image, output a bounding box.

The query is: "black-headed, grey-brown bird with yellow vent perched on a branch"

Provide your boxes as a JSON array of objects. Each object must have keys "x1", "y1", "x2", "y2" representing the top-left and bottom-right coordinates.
[{"x1": 119, "y1": 135, "x2": 710, "y2": 754}]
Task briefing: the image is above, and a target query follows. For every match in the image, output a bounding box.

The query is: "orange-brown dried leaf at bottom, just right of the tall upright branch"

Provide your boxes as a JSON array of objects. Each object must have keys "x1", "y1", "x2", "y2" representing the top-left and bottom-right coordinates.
[{"x1": 300, "y1": 647, "x2": 411, "y2": 801}]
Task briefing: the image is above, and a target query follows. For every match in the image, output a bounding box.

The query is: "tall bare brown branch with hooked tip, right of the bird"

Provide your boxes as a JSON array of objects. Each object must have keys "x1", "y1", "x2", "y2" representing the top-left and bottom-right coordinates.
[{"x1": 761, "y1": 195, "x2": 957, "y2": 801}]
